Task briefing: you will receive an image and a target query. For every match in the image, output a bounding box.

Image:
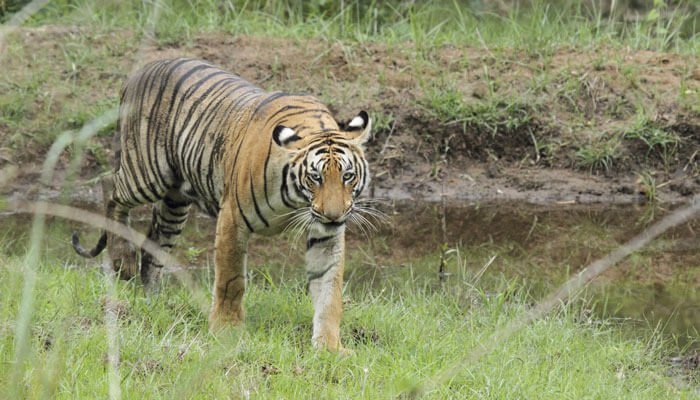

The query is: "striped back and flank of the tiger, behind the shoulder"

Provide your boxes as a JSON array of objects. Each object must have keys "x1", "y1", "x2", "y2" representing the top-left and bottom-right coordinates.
[{"x1": 115, "y1": 59, "x2": 274, "y2": 215}]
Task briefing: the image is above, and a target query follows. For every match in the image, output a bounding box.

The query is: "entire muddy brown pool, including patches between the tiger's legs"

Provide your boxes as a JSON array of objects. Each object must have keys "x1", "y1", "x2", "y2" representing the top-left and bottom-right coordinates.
[{"x1": 0, "y1": 203, "x2": 700, "y2": 348}]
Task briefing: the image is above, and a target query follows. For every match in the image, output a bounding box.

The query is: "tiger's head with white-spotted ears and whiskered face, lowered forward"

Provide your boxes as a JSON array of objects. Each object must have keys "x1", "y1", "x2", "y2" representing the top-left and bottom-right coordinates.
[{"x1": 273, "y1": 111, "x2": 372, "y2": 232}]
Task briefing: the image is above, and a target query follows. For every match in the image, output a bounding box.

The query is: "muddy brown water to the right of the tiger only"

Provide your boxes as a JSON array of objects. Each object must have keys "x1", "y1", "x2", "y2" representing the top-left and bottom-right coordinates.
[{"x1": 366, "y1": 203, "x2": 700, "y2": 349}]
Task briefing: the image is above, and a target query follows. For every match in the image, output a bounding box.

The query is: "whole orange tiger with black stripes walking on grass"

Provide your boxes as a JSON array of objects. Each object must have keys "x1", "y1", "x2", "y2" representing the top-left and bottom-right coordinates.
[{"x1": 72, "y1": 58, "x2": 372, "y2": 351}]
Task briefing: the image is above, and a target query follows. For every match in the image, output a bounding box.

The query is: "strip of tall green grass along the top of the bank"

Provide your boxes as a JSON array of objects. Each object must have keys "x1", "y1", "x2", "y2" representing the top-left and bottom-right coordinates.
[{"x1": 21, "y1": 0, "x2": 699, "y2": 54}]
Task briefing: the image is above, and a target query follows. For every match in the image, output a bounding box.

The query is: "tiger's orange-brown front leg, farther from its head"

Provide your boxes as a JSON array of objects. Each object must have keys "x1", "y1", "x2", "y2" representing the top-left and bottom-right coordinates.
[{"x1": 209, "y1": 204, "x2": 248, "y2": 331}]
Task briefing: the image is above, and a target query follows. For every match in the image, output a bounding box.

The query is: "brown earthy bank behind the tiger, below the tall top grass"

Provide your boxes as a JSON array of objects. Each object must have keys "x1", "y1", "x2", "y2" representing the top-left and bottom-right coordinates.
[{"x1": 0, "y1": 26, "x2": 700, "y2": 204}]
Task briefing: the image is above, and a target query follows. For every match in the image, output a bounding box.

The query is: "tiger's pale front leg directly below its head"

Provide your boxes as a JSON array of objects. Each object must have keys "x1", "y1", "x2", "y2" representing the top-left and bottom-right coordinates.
[{"x1": 306, "y1": 228, "x2": 345, "y2": 351}]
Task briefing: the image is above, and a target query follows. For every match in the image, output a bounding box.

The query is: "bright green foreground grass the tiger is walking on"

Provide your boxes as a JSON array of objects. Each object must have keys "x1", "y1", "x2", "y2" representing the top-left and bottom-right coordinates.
[{"x1": 0, "y1": 248, "x2": 693, "y2": 399}]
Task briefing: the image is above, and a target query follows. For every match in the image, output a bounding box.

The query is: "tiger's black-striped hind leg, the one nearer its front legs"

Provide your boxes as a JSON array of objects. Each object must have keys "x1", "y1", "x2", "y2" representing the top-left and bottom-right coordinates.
[{"x1": 141, "y1": 190, "x2": 191, "y2": 289}]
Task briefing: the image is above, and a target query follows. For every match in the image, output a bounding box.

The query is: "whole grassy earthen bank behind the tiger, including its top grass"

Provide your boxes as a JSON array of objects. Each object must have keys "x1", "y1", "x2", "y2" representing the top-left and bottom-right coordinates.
[{"x1": 0, "y1": 0, "x2": 700, "y2": 177}]
